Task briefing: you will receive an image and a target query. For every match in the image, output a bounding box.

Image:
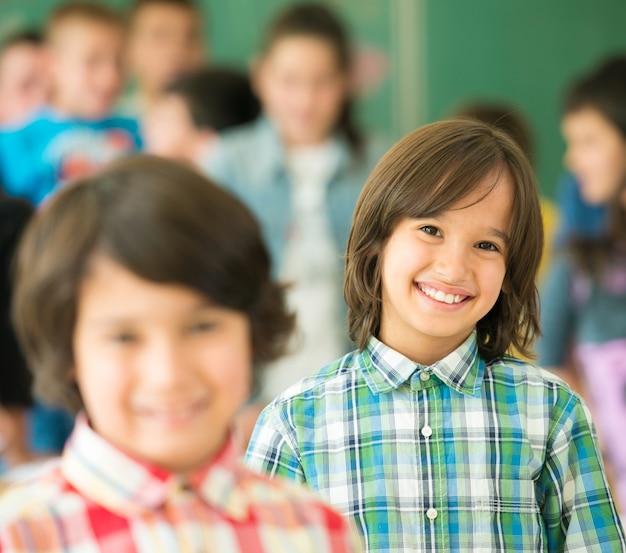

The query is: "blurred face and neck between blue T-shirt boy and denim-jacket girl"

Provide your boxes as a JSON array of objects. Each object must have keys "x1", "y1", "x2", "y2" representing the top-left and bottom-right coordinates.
[{"x1": 125, "y1": 0, "x2": 206, "y2": 114}]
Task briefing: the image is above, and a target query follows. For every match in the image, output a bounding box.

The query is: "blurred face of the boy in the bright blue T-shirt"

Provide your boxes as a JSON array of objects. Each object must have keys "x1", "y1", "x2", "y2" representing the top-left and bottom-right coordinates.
[{"x1": 50, "y1": 19, "x2": 123, "y2": 119}]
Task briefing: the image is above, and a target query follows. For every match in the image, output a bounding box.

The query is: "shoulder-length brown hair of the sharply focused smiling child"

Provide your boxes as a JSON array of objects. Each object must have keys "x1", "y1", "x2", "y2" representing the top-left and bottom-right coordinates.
[{"x1": 344, "y1": 119, "x2": 543, "y2": 360}]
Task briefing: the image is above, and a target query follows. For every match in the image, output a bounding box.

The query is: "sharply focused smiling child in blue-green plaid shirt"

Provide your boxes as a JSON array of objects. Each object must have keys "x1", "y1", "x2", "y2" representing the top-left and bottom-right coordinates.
[{"x1": 247, "y1": 120, "x2": 626, "y2": 553}]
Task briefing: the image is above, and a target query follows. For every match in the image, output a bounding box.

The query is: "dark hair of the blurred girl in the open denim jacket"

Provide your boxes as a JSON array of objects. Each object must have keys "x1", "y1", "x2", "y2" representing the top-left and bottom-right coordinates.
[{"x1": 261, "y1": 4, "x2": 363, "y2": 156}]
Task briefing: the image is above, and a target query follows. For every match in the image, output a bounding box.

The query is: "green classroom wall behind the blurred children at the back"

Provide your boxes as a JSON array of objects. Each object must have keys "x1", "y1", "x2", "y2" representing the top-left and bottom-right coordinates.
[{"x1": 0, "y1": 0, "x2": 626, "y2": 196}]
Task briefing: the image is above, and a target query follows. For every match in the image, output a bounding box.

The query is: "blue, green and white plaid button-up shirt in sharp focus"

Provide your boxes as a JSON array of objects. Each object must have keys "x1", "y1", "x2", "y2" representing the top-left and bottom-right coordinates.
[{"x1": 246, "y1": 334, "x2": 626, "y2": 553}]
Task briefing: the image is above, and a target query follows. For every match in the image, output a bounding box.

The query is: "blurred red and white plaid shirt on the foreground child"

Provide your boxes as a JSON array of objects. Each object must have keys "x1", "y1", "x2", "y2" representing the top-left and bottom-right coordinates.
[{"x1": 0, "y1": 416, "x2": 361, "y2": 553}]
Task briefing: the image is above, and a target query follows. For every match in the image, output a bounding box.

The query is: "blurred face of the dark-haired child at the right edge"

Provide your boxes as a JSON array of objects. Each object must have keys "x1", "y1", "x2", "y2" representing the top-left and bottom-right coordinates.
[{"x1": 563, "y1": 108, "x2": 626, "y2": 205}]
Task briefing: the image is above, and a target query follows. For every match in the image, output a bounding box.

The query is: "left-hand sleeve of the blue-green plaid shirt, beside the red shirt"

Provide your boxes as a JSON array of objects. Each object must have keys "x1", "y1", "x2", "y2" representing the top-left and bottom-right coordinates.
[{"x1": 245, "y1": 403, "x2": 306, "y2": 483}]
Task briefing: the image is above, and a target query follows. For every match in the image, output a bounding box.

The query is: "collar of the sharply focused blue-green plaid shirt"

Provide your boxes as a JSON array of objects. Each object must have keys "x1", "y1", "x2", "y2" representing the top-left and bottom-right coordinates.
[{"x1": 360, "y1": 332, "x2": 485, "y2": 396}]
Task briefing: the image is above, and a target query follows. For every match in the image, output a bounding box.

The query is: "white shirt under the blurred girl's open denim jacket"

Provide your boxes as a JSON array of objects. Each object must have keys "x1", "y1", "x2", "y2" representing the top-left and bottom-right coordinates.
[{"x1": 263, "y1": 141, "x2": 345, "y2": 399}]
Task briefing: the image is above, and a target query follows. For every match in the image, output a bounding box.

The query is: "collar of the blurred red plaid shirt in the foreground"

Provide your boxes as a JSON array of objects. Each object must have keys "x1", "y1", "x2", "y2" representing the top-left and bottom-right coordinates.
[{"x1": 61, "y1": 413, "x2": 249, "y2": 520}]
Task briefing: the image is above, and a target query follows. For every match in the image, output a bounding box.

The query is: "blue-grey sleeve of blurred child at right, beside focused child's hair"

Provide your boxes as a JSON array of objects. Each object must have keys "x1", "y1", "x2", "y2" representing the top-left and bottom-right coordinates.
[{"x1": 537, "y1": 256, "x2": 576, "y2": 367}]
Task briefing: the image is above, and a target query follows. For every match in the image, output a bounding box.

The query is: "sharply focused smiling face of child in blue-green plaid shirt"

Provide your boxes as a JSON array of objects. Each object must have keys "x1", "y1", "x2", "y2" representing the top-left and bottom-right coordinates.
[{"x1": 379, "y1": 173, "x2": 512, "y2": 365}]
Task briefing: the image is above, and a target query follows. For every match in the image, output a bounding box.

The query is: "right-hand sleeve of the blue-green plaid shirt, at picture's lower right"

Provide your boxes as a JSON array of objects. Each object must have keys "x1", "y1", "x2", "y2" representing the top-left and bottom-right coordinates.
[{"x1": 539, "y1": 392, "x2": 626, "y2": 553}]
